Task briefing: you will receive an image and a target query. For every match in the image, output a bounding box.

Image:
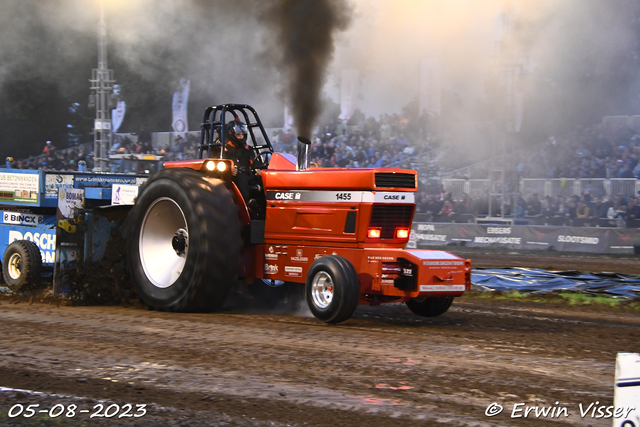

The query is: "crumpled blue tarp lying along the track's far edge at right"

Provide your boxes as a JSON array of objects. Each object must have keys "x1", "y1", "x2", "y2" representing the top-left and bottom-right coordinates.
[{"x1": 471, "y1": 268, "x2": 640, "y2": 298}]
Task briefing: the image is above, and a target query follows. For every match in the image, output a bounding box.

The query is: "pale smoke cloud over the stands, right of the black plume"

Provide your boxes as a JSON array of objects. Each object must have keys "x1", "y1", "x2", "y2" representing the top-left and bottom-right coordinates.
[{"x1": 328, "y1": 0, "x2": 640, "y2": 163}]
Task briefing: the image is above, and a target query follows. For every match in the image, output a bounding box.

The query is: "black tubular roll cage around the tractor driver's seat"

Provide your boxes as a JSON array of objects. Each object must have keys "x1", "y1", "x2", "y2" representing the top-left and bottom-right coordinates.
[{"x1": 198, "y1": 104, "x2": 273, "y2": 168}]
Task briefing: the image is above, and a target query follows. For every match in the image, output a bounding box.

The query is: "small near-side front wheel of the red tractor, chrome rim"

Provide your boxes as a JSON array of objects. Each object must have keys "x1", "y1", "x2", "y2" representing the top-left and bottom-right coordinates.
[{"x1": 305, "y1": 255, "x2": 360, "y2": 323}]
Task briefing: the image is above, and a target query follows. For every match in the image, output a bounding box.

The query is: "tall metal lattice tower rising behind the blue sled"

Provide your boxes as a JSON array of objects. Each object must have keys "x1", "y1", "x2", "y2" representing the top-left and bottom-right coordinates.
[{"x1": 90, "y1": 0, "x2": 115, "y2": 172}]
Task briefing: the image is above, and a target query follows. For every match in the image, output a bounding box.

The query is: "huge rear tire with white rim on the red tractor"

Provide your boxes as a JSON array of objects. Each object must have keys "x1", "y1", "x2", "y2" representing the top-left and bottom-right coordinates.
[{"x1": 127, "y1": 169, "x2": 242, "y2": 312}]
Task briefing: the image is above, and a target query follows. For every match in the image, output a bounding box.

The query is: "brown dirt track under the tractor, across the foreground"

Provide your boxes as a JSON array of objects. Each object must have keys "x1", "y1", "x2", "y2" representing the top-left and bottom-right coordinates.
[{"x1": 0, "y1": 252, "x2": 640, "y2": 426}]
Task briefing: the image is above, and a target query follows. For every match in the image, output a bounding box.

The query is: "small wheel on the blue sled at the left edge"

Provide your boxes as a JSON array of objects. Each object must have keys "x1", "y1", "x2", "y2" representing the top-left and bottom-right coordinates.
[{"x1": 2, "y1": 240, "x2": 42, "y2": 292}]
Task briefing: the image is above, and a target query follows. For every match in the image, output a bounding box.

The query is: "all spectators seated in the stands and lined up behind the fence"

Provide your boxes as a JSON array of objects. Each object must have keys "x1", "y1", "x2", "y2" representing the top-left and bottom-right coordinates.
[{"x1": 6, "y1": 108, "x2": 640, "y2": 226}]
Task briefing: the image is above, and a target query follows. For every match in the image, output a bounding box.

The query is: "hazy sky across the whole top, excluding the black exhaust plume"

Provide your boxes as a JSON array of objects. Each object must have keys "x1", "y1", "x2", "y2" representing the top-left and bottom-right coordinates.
[{"x1": 0, "y1": 0, "x2": 640, "y2": 140}]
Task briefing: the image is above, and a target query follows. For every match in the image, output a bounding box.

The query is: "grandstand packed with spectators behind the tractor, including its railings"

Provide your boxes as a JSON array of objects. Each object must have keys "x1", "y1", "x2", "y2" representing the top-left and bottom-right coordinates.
[{"x1": 14, "y1": 114, "x2": 640, "y2": 231}]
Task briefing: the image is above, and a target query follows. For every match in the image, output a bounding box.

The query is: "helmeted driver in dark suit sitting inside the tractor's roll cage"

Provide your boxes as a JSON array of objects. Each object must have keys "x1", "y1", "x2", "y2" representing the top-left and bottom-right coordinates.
[{"x1": 223, "y1": 118, "x2": 262, "y2": 213}]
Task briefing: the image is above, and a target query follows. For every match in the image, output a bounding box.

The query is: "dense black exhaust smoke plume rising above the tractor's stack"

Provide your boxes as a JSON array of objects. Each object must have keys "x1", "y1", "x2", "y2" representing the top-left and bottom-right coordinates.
[{"x1": 261, "y1": 0, "x2": 351, "y2": 137}]
